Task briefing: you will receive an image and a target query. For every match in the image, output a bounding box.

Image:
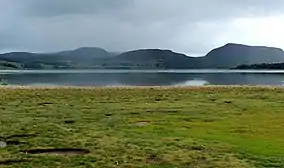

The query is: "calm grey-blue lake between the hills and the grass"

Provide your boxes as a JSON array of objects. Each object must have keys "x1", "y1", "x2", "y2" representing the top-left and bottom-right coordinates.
[{"x1": 0, "y1": 70, "x2": 284, "y2": 86}]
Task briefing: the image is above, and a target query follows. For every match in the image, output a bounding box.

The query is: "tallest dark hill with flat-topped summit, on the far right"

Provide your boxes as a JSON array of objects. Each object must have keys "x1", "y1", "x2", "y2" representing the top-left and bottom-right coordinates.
[{"x1": 203, "y1": 43, "x2": 284, "y2": 68}]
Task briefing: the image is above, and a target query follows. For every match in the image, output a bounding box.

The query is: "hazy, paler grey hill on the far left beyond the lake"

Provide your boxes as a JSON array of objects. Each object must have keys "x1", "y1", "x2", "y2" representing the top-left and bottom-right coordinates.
[{"x1": 0, "y1": 47, "x2": 115, "y2": 69}]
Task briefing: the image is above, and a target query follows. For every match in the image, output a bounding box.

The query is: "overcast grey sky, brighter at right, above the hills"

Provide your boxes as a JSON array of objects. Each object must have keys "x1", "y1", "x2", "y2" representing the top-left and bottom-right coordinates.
[{"x1": 0, "y1": 0, "x2": 284, "y2": 55}]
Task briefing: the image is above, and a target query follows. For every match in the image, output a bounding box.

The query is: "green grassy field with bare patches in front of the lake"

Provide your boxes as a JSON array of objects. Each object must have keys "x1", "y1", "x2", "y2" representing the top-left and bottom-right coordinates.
[{"x1": 0, "y1": 87, "x2": 284, "y2": 168}]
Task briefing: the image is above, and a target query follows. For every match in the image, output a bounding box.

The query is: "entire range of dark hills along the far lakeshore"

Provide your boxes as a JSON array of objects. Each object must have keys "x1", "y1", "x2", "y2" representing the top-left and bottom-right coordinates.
[{"x1": 0, "y1": 43, "x2": 284, "y2": 69}]
